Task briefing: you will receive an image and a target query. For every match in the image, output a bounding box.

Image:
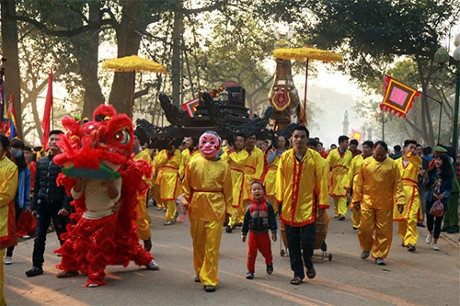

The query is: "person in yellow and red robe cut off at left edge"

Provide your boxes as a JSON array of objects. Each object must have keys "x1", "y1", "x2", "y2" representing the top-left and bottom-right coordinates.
[{"x1": 0, "y1": 134, "x2": 18, "y2": 305}]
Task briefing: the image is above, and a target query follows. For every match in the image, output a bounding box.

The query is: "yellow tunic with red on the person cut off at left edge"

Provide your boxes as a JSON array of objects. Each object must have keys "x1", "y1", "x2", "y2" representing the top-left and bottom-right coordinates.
[{"x1": 0, "y1": 156, "x2": 18, "y2": 249}]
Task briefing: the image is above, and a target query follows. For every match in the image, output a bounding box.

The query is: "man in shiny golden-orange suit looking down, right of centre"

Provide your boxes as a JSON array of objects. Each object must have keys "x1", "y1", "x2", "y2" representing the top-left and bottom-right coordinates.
[{"x1": 352, "y1": 141, "x2": 406, "y2": 265}]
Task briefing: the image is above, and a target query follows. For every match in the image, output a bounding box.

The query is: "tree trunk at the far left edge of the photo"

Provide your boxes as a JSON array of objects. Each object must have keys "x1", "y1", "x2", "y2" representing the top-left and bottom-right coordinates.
[{"x1": 0, "y1": 0, "x2": 23, "y2": 138}]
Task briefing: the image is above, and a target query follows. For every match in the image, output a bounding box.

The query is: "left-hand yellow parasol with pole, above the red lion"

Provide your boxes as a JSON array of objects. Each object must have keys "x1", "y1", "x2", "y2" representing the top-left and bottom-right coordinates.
[{"x1": 102, "y1": 55, "x2": 166, "y2": 116}]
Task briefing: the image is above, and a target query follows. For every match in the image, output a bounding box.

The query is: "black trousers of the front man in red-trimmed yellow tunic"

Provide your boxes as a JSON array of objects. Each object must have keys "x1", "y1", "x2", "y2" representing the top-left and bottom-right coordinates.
[{"x1": 284, "y1": 223, "x2": 315, "y2": 279}]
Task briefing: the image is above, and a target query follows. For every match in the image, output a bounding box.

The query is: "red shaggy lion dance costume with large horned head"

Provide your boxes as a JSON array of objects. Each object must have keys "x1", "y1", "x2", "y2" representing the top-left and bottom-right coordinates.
[{"x1": 54, "y1": 105, "x2": 158, "y2": 287}]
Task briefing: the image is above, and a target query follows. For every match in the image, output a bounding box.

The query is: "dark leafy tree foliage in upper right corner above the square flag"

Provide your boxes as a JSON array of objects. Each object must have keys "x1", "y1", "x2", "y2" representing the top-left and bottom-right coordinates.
[{"x1": 300, "y1": 0, "x2": 460, "y2": 144}]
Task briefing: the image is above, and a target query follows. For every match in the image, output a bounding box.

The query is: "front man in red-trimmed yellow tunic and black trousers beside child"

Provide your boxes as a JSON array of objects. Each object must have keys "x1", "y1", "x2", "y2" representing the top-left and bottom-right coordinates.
[{"x1": 276, "y1": 125, "x2": 329, "y2": 285}]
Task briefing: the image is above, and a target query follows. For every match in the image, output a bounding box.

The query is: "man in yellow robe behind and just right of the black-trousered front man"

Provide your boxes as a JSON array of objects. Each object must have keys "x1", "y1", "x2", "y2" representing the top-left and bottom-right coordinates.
[{"x1": 327, "y1": 135, "x2": 353, "y2": 221}]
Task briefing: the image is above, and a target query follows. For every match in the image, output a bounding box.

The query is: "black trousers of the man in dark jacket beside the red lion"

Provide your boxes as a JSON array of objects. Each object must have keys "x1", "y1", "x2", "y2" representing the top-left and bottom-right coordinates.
[{"x1": 32, "y1": 202, "x2": 68, "y2": 267}]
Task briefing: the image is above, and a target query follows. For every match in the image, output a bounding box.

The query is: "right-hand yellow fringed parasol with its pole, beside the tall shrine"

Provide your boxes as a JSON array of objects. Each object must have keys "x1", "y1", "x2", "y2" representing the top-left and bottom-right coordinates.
[{"x1": 273, "y1": 47, "x2": 342, "y2": 124}]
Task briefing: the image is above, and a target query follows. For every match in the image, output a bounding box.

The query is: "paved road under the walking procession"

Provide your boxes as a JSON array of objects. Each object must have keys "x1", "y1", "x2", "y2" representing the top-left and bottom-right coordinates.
[{"x1": 5, "y1": 202, "x2": 460, "y2": 305}]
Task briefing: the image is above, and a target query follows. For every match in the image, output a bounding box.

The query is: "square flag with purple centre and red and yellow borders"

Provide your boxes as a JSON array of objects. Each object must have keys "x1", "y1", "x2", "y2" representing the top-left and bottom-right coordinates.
[{"x1": 380, "y1": 75, "x2": 420, "y2": 119}]
